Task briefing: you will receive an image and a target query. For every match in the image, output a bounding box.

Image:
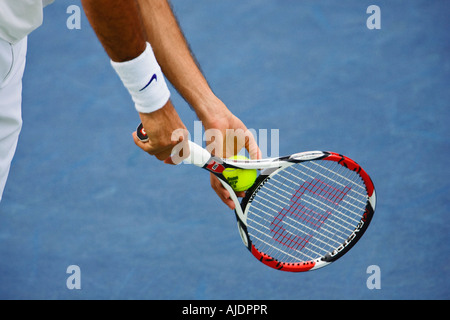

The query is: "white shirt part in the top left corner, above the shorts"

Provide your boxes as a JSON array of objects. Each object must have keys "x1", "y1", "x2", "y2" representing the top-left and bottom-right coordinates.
[{"x1": 0, "y1": 0, "x2": 54, "y2": 43}]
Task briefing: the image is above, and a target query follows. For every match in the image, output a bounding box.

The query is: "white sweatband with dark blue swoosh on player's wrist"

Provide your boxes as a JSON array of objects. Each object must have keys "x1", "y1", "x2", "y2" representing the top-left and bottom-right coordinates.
[{"x1": 111, "y1": 43, "x2": 170, "y2": 113}]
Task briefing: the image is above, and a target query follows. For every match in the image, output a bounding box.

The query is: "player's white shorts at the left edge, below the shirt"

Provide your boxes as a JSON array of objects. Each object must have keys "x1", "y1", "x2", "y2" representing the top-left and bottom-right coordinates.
[{"x1": 0, "y1": 38, "x2": 27, "y2": 201}]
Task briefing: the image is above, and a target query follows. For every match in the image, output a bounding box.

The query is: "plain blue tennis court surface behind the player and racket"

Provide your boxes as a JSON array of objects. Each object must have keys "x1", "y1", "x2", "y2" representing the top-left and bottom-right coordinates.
[{"x1": 0, "y1": 0, "x2": 450, "y2": 300}]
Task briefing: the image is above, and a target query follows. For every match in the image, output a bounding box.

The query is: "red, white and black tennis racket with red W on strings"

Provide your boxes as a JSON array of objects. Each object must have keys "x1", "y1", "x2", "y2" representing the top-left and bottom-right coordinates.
[{"x1": 137, "y1": 124, "x2": 376, "y2": 272}]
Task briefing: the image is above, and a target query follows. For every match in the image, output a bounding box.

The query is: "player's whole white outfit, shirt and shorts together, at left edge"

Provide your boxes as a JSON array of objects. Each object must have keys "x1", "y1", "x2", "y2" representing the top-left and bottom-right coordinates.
[{"x1": 0, "y1": 0, "x2": 54, "y2": 201}]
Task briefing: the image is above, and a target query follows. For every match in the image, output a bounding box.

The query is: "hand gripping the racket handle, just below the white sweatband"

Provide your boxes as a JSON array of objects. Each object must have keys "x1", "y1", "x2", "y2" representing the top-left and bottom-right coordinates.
[{"x1": 133, "y1": 100, "x2": 187, "y2": 164}]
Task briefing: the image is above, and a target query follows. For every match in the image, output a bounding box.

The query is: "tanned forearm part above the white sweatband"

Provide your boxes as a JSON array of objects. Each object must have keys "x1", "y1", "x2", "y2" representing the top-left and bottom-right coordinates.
[{"x1": 81, "y1": 0, "x2": 146, "y2": 62}]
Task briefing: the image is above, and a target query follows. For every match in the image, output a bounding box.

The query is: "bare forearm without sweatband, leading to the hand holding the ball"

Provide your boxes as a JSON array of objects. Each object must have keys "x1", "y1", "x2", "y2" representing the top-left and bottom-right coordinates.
[{"x1": 137, "y1": 0, "x2": 226, "y2": 120}]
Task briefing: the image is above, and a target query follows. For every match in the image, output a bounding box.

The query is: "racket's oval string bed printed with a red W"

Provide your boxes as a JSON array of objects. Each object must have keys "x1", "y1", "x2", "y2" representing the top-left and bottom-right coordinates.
[{"x1": 247, "y1": 161, "x2": 367, "y2": 263}]
